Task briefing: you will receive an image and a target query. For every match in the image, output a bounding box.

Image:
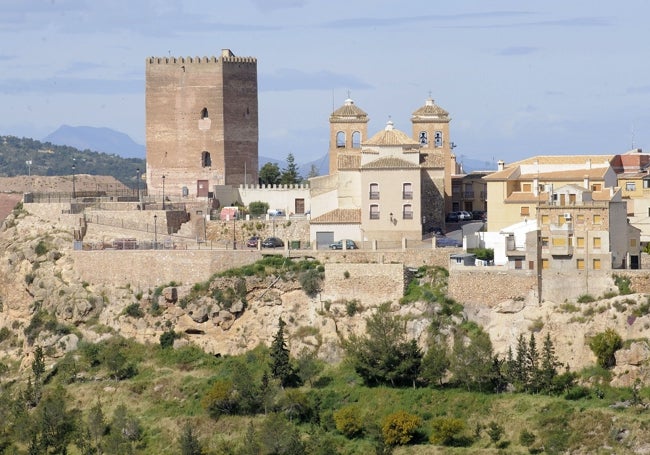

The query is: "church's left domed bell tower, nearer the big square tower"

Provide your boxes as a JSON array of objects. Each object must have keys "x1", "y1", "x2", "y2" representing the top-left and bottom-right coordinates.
[{"x1": 329, "y1": 98, "x2": 369, "y2": 174}]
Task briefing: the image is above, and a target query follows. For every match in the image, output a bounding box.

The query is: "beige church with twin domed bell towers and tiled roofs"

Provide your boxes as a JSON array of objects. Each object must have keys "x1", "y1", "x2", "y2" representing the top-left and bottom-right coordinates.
[{"x1": 309, "y1": 95, "x2": 456, "y2": 247}]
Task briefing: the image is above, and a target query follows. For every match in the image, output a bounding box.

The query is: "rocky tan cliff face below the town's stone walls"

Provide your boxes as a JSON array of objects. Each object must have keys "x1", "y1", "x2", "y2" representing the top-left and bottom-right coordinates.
[{"x1": 0, "y1": 205, "x2": 650, "y2": 385}]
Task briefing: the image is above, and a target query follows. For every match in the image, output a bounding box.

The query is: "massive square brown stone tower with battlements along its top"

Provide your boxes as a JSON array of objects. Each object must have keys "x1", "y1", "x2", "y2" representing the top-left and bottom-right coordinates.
[{"x1": 145, "y1": 49, "x2": 258, "y2": 198}]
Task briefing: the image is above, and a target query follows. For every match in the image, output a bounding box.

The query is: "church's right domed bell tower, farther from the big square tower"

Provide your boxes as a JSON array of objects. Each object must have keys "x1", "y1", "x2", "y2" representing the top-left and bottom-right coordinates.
[{"x1": 411, "y1": 98, "x2": 456, "y2": 213}]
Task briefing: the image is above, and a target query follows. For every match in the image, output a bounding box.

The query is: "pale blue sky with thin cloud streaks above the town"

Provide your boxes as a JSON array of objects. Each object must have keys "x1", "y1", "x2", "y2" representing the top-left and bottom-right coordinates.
[{"x1": 0, "y1": 0, "x2": 650, "y2": 169}]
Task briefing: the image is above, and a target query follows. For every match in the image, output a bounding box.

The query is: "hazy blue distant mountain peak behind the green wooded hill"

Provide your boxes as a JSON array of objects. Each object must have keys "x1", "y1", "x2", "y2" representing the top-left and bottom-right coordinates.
[{"x1": 43, "y1": 125, "x2": 145, "y2": 158}]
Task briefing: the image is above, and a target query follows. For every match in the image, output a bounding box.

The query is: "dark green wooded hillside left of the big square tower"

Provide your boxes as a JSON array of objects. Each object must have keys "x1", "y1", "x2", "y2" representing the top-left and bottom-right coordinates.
[{"x1": 0, "y1": 136, "x2": 145, "y2": 188}]
